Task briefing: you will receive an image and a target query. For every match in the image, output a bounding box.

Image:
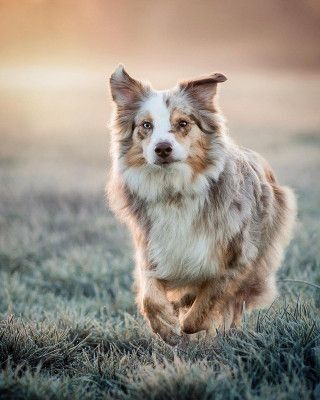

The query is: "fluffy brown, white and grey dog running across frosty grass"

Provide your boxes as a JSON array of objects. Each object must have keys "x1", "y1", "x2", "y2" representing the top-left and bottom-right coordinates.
[{"x1": 107, "y1": 66, "x2": 296, "y2": 343}]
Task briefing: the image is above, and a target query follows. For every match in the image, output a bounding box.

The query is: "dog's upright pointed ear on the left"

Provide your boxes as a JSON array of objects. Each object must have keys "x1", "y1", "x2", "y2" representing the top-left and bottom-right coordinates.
[{"x1": 110, "y1": 64, "x2": 148, "y2": 107}]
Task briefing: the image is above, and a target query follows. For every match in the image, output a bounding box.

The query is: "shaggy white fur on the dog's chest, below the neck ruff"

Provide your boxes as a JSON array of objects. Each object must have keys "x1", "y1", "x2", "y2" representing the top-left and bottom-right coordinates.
[{"x1": 148, "y1": 198, "x2": 218, "y2": 282}]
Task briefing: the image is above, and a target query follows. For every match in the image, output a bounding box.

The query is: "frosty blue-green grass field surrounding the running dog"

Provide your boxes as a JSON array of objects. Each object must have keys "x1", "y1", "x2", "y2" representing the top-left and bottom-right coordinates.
[{"x1": 0, "y1": 73, "x2": 320, "y2": 400}]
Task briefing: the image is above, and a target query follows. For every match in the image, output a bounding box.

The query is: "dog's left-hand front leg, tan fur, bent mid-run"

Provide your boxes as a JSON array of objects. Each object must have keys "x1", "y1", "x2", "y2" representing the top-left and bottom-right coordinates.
[{"x1": 138, "y1": 271, "x2": 180, "y2": 345}]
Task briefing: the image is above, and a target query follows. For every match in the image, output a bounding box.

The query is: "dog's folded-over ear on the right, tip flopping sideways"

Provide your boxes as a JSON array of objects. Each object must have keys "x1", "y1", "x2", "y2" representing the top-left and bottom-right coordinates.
[{"x1": 179, "y1": 73, "x2": 227, "y2": 108}]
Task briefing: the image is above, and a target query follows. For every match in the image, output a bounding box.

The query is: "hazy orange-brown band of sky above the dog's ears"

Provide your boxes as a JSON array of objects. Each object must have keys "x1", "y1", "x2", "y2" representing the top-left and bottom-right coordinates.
[{"x1": 0, "y1": 0, "x2": 320, "y2": 70}]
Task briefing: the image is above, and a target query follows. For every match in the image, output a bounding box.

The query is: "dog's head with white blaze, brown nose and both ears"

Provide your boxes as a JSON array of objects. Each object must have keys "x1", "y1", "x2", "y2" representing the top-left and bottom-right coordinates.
[{"x1": 110, "y1": 66, "x2": 226, "y2": 177}]
